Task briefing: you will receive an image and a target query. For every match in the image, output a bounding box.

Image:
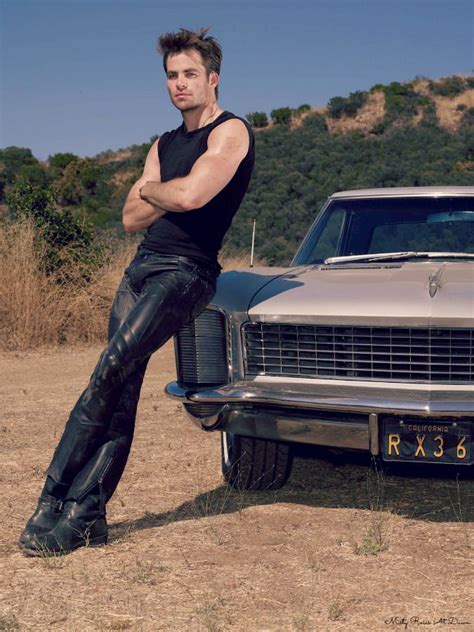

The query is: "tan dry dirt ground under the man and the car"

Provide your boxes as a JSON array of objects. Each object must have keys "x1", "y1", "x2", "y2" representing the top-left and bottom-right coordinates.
[{"x1": 0, "y1": 345, "x2": 474, "y2": 632}]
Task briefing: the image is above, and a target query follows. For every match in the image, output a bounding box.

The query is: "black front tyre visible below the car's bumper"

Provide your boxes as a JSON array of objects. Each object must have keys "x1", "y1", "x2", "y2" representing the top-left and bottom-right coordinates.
[{"x1": 221, "y1": 432, "x2": 292, "y2": 490}]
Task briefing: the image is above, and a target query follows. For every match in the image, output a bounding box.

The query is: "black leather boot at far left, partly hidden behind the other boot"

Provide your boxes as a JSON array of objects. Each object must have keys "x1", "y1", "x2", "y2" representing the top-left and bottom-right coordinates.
[{"x1": 18, "y1": 476, "x2": 69, "y2": 548}]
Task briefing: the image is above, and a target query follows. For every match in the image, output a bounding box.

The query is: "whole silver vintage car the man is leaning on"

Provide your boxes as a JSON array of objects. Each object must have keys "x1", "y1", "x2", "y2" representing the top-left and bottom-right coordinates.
[{"x1": 166, "y1": 187, "x2": 474, "y2": 489}]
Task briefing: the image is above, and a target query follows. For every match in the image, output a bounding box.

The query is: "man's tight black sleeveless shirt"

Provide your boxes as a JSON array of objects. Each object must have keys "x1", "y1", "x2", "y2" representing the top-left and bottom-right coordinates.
[{"x1": 141, "y1": 112, "x2": 255, "y2": 265}]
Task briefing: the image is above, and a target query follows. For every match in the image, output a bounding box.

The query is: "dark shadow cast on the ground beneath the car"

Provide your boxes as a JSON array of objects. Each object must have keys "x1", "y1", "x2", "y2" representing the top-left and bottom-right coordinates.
[{"x1": 110, "y1": 447, "x2": 474, "y2": 541}]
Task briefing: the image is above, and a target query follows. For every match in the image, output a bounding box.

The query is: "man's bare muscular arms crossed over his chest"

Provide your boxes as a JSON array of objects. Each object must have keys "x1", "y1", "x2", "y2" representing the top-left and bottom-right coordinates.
[{"x1": 122, "y1": 119, "x2": 249, "y2": 233}]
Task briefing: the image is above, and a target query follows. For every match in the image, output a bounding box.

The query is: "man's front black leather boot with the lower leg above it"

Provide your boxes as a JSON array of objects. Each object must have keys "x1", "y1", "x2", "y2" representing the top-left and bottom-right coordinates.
[{"x1": 22, "y1": 441, "x2": 128, "y2": 557}]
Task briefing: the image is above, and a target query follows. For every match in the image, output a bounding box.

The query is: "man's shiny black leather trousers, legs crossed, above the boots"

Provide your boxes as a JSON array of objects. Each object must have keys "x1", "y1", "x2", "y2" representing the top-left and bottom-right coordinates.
[{"x1": 42, "y1": 248, "x2": 219, "y2": 513}]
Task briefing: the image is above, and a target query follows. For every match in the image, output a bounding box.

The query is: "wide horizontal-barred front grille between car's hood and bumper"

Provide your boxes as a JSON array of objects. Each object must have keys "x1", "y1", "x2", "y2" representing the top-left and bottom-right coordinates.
[{"x1": 244, "y1": 323, "x2": 474, "y2": 382}]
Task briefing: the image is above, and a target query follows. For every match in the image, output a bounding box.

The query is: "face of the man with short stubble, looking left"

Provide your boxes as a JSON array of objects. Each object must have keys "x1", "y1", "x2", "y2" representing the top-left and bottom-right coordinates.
[{"x1": 166, "y1": 49, "x2": 219, "y2": 112}]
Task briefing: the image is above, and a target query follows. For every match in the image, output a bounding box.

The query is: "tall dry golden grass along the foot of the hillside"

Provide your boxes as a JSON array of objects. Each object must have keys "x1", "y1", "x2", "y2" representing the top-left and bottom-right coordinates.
[{"x1": 0, "y1": 222, "x2": 262, "y2": 350}]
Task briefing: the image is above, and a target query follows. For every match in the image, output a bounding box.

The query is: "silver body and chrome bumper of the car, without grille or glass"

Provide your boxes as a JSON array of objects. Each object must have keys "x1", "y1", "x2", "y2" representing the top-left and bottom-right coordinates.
[{"x1": 166, "y1": 187, "x2": 474, "y2": 464}]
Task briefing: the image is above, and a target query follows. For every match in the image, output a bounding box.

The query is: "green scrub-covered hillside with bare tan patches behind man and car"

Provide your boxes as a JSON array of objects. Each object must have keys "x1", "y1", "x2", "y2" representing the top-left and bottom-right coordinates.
[{"x1": 0, "y1": 76, "x2": 474, "y2": 263}]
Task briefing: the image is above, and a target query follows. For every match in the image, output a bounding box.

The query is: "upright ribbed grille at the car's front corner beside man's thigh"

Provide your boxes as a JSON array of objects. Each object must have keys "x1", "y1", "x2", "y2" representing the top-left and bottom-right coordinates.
[{"x1": 175, "y1": 309, "x2": 228, "y2": 387}]
